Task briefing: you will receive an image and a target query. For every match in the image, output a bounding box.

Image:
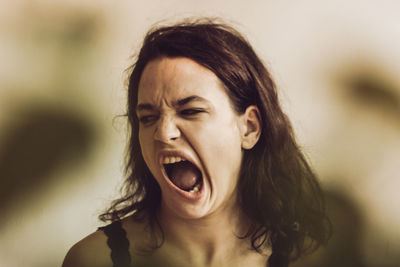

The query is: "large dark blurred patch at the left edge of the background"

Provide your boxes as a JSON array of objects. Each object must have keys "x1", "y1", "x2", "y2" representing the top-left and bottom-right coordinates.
[{"x1": 0, "y1": 106, "x2": 96, "y2": 227}]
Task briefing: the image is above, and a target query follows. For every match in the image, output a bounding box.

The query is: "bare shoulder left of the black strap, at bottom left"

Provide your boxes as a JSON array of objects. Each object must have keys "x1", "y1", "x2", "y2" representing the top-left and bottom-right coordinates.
[{"x1": 62, "y1": 231, "x2": 112, "y2": 267}]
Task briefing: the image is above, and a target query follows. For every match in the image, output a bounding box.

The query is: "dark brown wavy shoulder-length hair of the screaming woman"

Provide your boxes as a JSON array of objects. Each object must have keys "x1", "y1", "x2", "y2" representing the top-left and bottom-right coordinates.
[{"x1": 99, "y1": 19, "x2": 330, "y2": 267}]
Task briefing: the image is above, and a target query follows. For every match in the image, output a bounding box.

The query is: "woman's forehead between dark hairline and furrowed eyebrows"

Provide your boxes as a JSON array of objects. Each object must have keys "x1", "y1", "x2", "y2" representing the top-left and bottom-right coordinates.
[{"x1": 138, "y1": 57, "x2": 229, "y2": 105}]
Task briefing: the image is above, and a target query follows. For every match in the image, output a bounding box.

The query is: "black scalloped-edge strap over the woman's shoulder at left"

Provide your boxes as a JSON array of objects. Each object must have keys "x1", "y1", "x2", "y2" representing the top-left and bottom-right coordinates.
[{"x1": 99, "y1": 221, "x2": 131, "y2": 267}]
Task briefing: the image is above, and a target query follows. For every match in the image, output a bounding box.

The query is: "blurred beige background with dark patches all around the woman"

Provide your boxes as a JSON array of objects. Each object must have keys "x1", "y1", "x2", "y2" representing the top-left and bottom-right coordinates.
[{"x1": 0, "y1": 0, "x2": 400, "y2": 267}]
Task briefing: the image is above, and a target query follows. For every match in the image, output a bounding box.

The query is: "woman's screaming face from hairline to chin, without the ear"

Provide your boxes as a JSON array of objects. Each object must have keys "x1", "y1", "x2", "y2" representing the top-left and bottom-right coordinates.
[{"x1": 136, "y1": 57, "x2": 243, "y2": 219}]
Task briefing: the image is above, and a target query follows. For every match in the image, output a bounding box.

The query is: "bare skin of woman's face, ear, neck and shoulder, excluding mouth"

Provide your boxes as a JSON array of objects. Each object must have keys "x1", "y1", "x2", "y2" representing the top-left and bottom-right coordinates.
[{"x1": 63, "y1": 57, "x2": 271, "y2": 267}]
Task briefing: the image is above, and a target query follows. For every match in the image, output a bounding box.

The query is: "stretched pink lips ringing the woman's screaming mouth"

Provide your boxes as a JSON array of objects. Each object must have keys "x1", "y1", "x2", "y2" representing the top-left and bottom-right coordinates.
[{"x1": 157, "y1": 150, "x2": 205, "y2": 200}]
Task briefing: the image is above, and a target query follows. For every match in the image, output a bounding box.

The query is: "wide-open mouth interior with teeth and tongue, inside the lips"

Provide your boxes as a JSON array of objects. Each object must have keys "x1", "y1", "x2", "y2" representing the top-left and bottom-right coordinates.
[{"x1": 163, "y1": 157, "x2": 203, "y2": 193}]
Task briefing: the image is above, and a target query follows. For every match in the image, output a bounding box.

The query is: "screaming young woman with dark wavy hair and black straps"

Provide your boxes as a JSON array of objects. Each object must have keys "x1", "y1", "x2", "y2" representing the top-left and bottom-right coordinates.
[{"x1": 63, "y1": 21, "x2": 329, "y2": 267}]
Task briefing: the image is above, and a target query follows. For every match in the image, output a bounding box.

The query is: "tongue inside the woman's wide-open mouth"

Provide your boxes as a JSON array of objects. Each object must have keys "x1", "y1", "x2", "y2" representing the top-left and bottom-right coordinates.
[{"x1": 170, "y1": 161, "x2": 200, "y2": 191}]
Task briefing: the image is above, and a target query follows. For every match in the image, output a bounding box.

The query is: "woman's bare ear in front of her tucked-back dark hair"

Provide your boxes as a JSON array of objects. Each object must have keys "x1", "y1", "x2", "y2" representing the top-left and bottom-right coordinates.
[{"x1": 240, "y1": 105, "x2": 262, "y2": 149}]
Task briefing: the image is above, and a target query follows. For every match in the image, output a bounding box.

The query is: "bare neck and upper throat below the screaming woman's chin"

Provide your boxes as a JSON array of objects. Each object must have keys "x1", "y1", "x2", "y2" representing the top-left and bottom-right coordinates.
[{"x1": 153, "y1": 198, "x2": 266, "y2": 266}]
